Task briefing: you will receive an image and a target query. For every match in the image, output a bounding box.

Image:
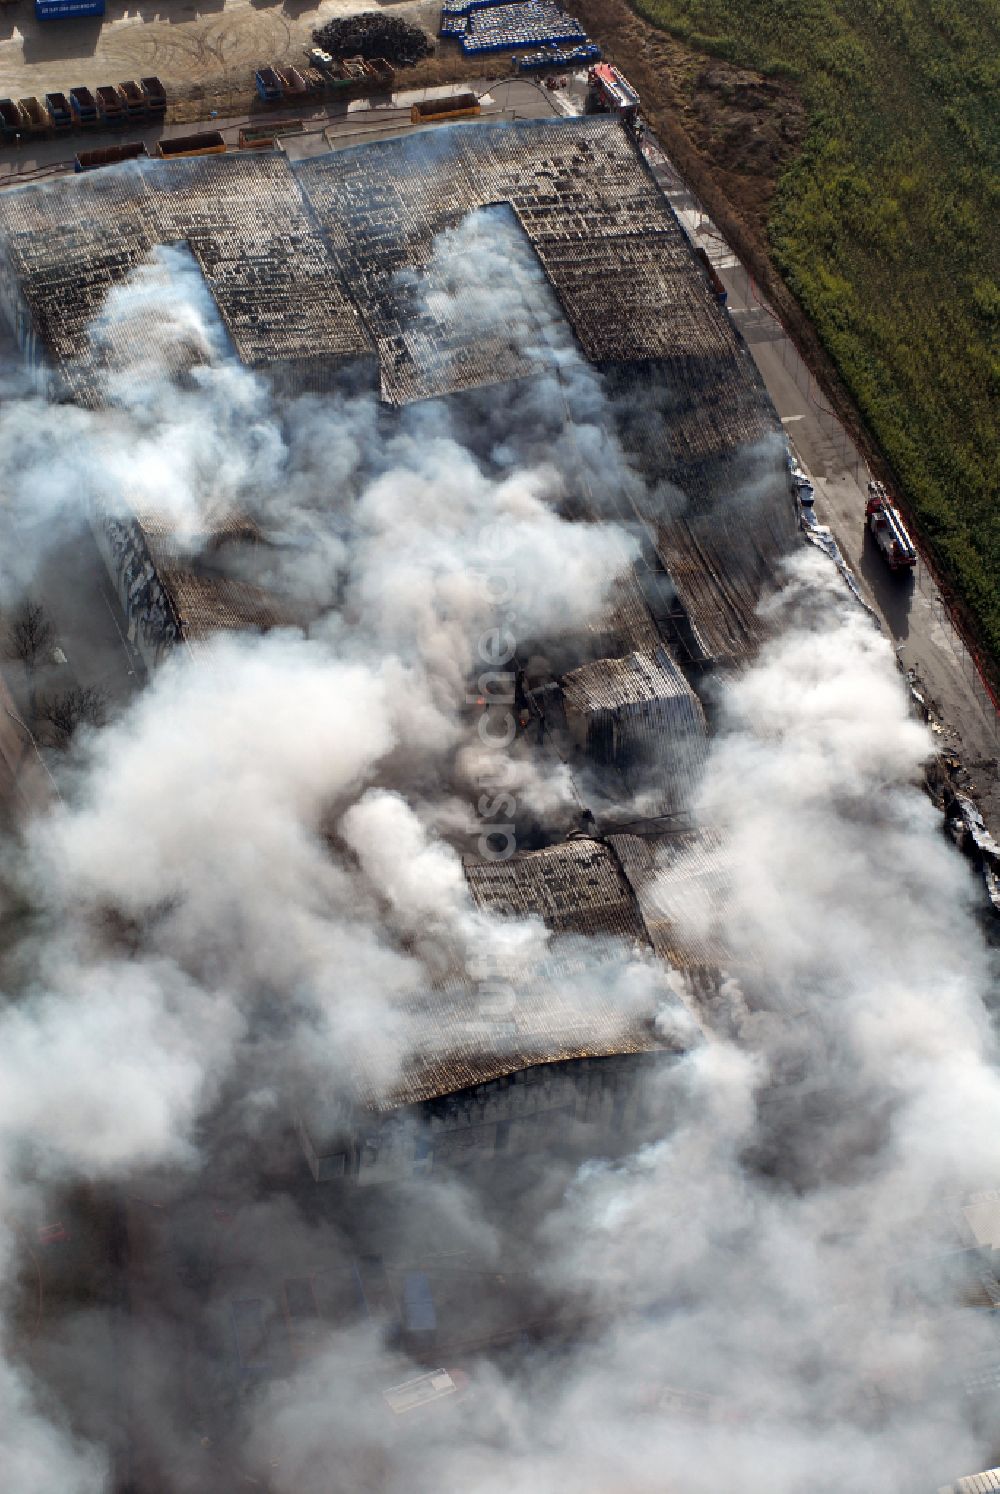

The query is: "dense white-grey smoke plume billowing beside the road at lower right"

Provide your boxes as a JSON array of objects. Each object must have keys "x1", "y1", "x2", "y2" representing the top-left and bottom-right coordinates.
[{"x1": 222, "y1": 556, "x2": 1000, "y2": 1494}]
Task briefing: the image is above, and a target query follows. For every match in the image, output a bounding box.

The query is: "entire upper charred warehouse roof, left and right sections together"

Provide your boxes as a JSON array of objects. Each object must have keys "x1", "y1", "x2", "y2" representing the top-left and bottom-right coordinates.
[{"x1": 0, "y1": 117, "x2": 795, "y2": 665}]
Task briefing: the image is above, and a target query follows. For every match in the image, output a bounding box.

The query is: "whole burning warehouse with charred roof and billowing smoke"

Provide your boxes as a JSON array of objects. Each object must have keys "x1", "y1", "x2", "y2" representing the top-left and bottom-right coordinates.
[{"x1": 0, "y1": 108, "x2": 1000, "y2": 1494}]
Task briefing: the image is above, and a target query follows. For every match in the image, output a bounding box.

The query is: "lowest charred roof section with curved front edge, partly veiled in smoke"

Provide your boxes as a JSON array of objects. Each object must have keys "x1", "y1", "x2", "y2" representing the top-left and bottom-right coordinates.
[{"x1": 297, "y1": 837, "x2": 704, "y2": 1182}]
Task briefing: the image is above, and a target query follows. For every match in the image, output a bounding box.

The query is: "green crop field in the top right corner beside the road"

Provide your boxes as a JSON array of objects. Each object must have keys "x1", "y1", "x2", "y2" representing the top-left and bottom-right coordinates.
[{"x1": 632, "y1": 0, "x2": 1000, "y2": 671}]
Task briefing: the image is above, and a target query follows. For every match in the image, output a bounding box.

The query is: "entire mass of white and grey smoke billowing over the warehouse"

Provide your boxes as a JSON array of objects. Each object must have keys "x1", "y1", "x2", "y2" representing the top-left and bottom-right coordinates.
[{"x1": 0, "y1": 213, "x2": 1000, "y2": 1494}]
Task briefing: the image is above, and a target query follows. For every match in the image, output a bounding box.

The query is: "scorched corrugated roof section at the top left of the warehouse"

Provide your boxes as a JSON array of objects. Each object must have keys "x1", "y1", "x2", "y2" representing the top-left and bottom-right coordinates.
[{"x1": 0, "y1": 152, "x2": 371, "y2": 405}]
